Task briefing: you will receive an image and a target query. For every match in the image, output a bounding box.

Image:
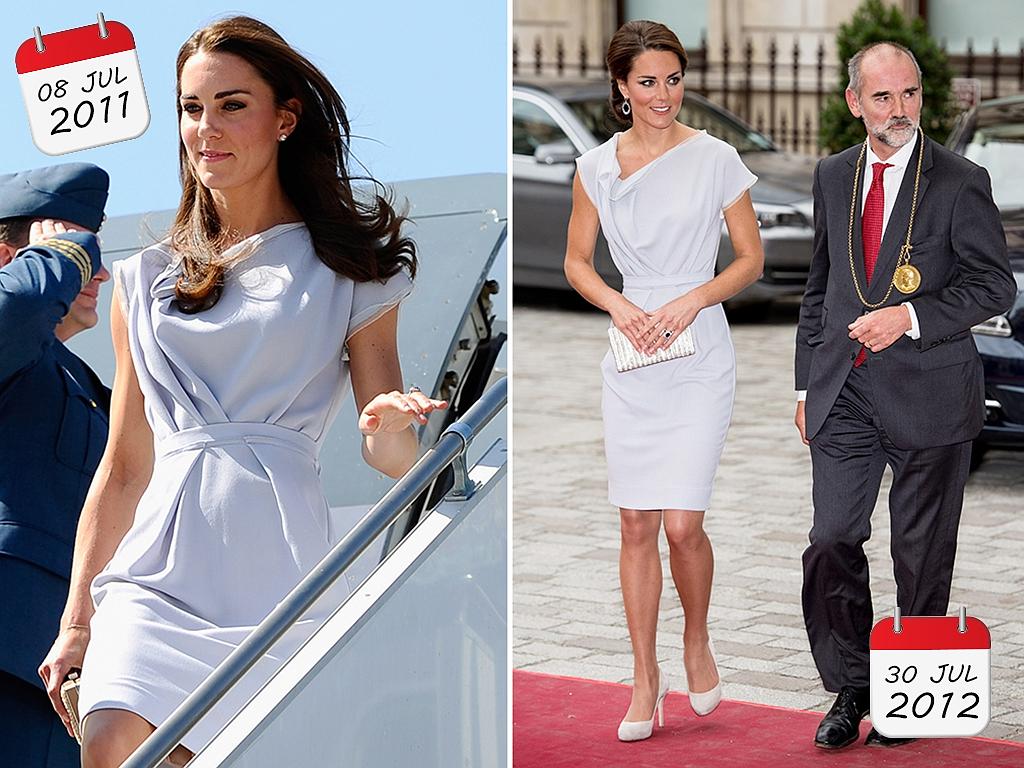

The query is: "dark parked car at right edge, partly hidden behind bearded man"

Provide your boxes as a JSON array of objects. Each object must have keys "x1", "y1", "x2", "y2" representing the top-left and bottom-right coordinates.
[{"x1": 946, "y1": 95, "x2": 1024, "y2": 465}]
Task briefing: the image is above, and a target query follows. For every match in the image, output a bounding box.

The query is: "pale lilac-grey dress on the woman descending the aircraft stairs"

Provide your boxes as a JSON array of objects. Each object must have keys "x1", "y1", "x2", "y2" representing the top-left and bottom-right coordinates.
[{"x1": 80, "y1": 223, "x2": 412, "y2": 752}]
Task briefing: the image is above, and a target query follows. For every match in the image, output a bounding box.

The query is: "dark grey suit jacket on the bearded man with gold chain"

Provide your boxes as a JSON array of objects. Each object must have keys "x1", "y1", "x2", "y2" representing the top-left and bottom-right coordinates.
[{"x1": 796, "y1": 137, "x2": 1017, "y2": 449}]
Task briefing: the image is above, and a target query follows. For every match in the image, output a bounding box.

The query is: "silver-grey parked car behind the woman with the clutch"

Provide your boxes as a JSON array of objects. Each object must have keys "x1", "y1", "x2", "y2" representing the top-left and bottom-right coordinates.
[{"x1": 512, "y1": 81, "x2": 815, "y2": 306}]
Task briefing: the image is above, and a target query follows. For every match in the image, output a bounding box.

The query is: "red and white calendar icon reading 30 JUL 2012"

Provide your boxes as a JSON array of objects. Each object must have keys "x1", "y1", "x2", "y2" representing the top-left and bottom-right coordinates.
[{"x1": 870, "y1": 608, "x2": 992, "y2": 738}]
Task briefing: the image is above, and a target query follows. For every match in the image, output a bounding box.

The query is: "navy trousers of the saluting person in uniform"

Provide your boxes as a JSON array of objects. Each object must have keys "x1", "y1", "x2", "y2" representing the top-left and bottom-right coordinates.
[{"x1": 0, "y1": 672, "x2": 82, "y2": 768}]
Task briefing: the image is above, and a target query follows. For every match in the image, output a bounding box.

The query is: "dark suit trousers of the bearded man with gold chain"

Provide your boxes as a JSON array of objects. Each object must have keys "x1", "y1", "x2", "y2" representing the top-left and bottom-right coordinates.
[{"x1": 803, "y1": 362, "x2": 971, "y2": 692}]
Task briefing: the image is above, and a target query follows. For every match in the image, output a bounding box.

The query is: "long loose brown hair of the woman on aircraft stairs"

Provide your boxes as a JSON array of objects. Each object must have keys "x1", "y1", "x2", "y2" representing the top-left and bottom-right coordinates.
[{"x1": 171, "y1": 16, "x2": 417, "y2": 312}]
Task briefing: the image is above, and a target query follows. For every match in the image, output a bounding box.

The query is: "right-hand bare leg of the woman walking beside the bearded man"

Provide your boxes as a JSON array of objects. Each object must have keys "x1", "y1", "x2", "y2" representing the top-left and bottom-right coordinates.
[{"x1": 665, "y1": 509, "x2": 718, "y2": 693}]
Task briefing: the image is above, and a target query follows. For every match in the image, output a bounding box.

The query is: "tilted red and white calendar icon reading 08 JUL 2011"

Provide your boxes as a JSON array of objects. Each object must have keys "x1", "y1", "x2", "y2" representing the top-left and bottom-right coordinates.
[{"x1": 14, "y1": 13, "x2": 150, "y2": 155}]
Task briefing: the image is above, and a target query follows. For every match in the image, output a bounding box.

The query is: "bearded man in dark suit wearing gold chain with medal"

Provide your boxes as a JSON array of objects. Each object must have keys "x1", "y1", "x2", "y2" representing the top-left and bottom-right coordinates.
[{"x1": 796, "y1": 43, "x2": 1016, "y2": 749}]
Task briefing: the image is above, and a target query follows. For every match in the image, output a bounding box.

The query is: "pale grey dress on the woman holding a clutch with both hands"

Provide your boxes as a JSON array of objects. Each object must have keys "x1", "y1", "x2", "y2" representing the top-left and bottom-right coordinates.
[{"x1": 577, "y1": 131, "x2": 757, "y2": 511}]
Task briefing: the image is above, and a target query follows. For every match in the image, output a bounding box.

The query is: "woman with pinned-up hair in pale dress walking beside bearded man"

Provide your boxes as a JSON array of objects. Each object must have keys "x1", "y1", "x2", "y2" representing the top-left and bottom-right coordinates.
[{"x1": 565, "y1": 22, "x2": 764, "y2": 741}]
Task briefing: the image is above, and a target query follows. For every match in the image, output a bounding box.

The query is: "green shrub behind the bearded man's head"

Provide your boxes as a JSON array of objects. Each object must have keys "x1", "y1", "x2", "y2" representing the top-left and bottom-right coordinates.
[{"x1": 818, "y1": 0, "x2": 955, "y2": 153}]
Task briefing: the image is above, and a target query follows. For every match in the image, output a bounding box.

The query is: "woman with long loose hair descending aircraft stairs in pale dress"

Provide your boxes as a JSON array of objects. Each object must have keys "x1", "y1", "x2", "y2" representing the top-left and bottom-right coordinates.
[{"x1": 40, "y1": 16, "x2": 445, "y2": 768}]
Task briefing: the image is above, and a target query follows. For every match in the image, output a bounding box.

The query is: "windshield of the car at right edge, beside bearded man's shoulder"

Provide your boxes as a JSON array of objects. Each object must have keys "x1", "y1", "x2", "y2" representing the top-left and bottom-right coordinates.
[{"x1": 964, "y1": 106, "x2": 1024, "y2": 210}]
